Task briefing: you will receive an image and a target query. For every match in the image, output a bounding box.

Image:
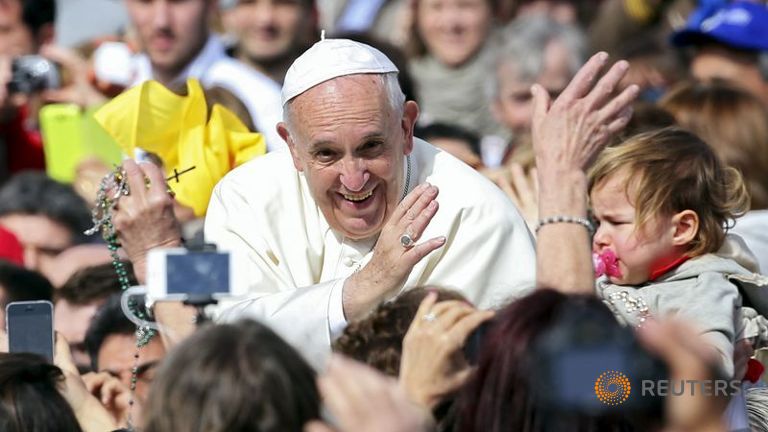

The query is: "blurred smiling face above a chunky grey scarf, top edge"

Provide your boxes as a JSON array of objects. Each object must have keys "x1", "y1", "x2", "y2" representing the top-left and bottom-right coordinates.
[{"x1": 416, "y1": 0, "x2": 491, "y2": 67}]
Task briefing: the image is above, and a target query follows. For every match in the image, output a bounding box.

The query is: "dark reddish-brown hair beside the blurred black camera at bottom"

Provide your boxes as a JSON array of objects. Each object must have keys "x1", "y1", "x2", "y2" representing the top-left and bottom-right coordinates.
[{"x1": 455, "y1": 289, "x2": 628, "y2": 432}]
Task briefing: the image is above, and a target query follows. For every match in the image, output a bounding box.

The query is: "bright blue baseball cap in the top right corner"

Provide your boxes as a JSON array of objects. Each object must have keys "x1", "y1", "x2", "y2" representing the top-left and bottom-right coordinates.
[{"x1": 672, "y1": 1, "x2": 768, "y2": 51}]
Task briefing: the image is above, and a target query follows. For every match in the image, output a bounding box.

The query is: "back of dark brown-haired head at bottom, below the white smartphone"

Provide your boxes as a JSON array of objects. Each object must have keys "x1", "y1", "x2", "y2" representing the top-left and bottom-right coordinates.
[{"x1": 145, "y1": 320, "x2": 320, "y2": 432}]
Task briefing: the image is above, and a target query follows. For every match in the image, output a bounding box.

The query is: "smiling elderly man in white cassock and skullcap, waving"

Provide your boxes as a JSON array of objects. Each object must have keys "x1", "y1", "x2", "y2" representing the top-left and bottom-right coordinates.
[{"x1": 115, "y1": 39, "x2": 536, "y2": 365}]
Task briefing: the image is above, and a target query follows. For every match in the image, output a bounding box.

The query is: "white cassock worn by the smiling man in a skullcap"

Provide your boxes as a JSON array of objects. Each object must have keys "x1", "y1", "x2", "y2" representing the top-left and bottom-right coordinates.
[{"x1": 205, "y1": 139, "x2": 536, "y2": 365}]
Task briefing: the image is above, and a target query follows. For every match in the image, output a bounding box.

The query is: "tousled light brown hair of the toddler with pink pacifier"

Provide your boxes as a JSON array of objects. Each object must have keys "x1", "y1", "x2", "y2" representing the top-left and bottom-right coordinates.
[{"x1": 589, "y1": 128, "x2": 749, "y2": 256}]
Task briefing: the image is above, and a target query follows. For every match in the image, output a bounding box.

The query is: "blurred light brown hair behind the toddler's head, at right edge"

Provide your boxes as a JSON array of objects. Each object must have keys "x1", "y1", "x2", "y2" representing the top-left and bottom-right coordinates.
[{"x1": 660, "y1": 81, "x2": 768, "y2": 210}]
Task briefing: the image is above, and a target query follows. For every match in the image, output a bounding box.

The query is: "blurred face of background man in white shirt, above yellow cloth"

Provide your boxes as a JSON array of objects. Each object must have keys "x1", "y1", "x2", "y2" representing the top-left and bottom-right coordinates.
[{"x1": 125, "y1": 0, "x2": 216, "y2": 80}]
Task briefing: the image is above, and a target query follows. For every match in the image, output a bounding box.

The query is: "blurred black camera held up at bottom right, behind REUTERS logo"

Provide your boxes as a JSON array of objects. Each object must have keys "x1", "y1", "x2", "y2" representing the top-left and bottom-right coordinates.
[{"x1": 530, "y1": 301, "x2": 668, "y2": 419}]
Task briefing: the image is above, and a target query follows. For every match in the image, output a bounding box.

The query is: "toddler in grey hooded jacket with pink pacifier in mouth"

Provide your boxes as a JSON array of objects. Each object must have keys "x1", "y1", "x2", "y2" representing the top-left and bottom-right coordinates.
[{"x1": 589, "y1": 128, "x2": 768, "y2": 379}]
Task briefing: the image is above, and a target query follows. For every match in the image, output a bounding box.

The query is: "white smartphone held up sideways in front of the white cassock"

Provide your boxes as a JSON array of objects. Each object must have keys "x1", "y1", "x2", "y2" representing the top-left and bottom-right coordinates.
[{"x1": 147, "y1": 248, "x2": 248, "y2": 301}]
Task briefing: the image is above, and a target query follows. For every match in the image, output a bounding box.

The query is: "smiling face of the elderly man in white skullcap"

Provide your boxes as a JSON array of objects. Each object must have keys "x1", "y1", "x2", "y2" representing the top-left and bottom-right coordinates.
[{"x1": 278, "y1": 74, "x2": 418, "y2": 240}]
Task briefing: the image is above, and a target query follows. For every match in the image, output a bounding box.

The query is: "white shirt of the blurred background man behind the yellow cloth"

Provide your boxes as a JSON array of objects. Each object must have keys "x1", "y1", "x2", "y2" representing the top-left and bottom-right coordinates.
[{"x1": 133, "y1": 35, "x2": 286, "y2": 151}]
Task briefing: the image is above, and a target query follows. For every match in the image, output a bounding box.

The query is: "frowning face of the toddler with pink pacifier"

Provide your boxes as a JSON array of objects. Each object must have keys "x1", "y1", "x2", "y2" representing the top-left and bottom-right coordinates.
[{"x1": 590, "y1": 172, "x2": 681, "y2": 285}]
